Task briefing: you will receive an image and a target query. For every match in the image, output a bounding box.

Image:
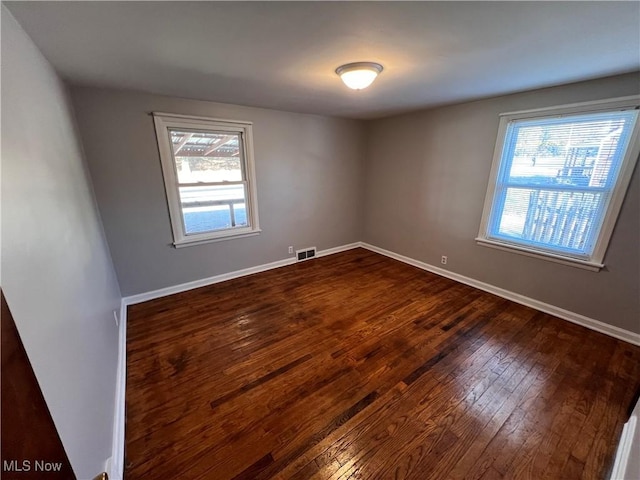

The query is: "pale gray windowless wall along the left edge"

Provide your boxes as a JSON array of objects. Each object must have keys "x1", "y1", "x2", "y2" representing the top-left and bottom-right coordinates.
[{"x1": 1, "y1": 6, "x2": 120, "y2": 479}]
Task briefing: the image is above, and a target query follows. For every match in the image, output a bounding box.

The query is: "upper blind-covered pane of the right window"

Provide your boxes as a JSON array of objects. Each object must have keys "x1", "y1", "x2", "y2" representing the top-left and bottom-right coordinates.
[{"x1": 506, "y1": 112, "x2": 634, "y2": 187}]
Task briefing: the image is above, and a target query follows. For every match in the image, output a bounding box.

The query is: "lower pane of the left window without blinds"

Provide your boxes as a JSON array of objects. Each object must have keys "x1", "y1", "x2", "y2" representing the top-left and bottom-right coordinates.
[{"x1": 180, "y1": 185, "x2": 248, "y2": 235}]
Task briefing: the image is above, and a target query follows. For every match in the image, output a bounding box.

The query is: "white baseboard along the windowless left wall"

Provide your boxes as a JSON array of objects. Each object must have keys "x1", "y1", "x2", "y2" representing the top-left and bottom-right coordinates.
[{"x1": 105, "y1": 299, "x2": 127, "y2": 480}]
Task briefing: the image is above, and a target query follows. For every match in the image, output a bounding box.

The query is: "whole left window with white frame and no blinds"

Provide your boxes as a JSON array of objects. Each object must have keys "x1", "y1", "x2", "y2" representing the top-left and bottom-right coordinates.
[{"x1": 153, "y1": 113, "x2": 260, "y2": 247}]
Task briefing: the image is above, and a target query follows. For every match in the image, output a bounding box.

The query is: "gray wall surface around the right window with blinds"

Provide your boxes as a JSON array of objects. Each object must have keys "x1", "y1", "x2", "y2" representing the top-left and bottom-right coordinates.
[{"x1": 363, "y1": 74, "x2": 640, "y2": 333}]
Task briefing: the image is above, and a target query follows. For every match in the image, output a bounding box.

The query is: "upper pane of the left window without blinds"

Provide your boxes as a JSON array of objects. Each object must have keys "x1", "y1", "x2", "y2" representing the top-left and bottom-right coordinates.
[{"x1": 169, "y1": 130, "x2": 243, "y2": 183}]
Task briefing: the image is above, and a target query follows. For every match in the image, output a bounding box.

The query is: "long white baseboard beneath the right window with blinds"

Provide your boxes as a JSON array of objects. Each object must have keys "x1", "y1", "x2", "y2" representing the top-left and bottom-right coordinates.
[{"x1": 360, "y1": 242, "x2": 640, "y2": 345}]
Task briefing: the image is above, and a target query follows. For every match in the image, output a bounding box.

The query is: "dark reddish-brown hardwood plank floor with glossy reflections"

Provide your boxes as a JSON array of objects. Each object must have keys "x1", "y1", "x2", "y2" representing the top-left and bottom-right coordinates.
[{"x1": 126, "y1": 249, "x2": 640, "y2": 480}]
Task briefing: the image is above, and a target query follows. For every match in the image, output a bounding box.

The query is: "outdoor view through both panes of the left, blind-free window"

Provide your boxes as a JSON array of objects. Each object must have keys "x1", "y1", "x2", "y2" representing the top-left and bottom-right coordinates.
[{"x1": 170, "y1": 129, "x2": 248, "y2": 235}]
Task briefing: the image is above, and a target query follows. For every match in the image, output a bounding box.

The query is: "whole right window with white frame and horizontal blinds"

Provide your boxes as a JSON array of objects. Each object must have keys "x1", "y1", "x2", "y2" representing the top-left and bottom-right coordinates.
[{"x1": 476, "y1": 97, "x2": 640, "y2": 271}]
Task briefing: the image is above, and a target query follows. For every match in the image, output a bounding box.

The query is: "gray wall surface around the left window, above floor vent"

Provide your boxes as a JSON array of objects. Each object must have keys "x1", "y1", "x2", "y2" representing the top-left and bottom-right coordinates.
[{"x1": 72, "y1": 88, "x2": 364, "y2": 295}]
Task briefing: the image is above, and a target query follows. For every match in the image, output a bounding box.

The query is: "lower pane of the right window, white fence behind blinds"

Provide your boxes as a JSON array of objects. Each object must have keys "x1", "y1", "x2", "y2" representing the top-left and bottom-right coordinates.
[{"x1": 497, "y1": 188, "x2": 605, "y2": 253}]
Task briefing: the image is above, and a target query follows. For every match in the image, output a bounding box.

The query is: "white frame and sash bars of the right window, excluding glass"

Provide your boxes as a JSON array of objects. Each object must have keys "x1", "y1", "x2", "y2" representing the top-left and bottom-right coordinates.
[{"x1": 476, "y1": 96, "x2": 640, "y2": 268}]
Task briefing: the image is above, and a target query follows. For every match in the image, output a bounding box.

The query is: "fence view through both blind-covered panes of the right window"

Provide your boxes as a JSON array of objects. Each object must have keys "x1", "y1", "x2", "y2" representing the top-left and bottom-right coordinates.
[{"x1": 492, "y1": 112, "x2": 635, "y2": 254}]
